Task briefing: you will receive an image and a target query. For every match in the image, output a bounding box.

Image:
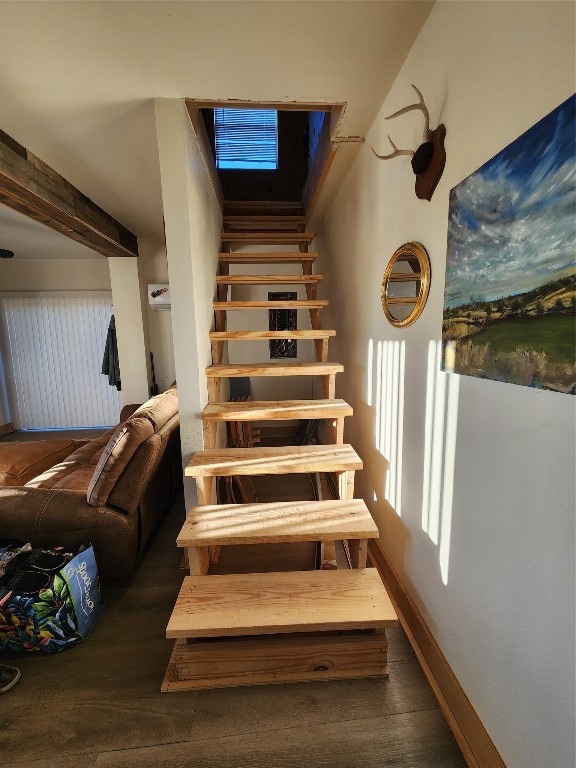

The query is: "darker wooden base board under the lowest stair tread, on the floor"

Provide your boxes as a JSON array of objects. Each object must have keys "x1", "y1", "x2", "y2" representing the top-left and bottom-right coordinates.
[{"x1": 162, "y1": 630, "x2": 388, "y2": 693}]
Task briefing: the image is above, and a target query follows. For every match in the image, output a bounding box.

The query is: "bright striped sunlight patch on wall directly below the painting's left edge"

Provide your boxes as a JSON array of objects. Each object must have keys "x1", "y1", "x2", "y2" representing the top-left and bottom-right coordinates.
[{"x1": 422, "y1": 341, "x2": 460, "y2": 584}]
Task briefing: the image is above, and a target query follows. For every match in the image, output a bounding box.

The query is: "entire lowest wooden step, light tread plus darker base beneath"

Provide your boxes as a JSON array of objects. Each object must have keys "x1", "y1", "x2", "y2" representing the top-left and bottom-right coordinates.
[{"x1": 162, "y1": 568, "x2": 398, "y2": 692}]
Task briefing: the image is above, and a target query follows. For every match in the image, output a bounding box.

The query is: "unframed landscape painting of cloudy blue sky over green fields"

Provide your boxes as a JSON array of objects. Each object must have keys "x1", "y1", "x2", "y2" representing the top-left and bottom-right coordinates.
[{"x1": 442, "y1": 96, "x2": 576, "y2": 394}]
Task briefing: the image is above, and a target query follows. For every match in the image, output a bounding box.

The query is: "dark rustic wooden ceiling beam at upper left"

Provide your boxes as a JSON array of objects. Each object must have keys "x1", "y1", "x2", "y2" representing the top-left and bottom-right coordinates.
[{"x1": 0, "y1": 130, "x2": 138, "y2": 256}]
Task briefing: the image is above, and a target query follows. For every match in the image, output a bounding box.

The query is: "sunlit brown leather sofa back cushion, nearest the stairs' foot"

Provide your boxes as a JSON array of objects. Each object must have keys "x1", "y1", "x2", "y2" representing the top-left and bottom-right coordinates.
[{"x1": 86, "y1": 416, "x2": 154, "y2": 507}]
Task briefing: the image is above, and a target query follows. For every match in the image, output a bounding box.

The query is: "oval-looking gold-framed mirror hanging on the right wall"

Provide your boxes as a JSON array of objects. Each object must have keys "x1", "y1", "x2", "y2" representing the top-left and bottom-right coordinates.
[{"x1": 381, "y1": 243, "x2": 430, "y2": 328}]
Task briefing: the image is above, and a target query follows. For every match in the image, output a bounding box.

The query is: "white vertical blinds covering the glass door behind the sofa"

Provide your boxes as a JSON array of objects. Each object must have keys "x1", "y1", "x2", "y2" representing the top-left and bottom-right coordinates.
[{"x1": 0, "y1": 297, "x2": 120, "y2": 429}]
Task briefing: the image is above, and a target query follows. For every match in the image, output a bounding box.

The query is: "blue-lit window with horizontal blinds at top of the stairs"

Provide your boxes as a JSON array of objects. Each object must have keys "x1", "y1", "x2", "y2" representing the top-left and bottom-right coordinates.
[{"x1": 214, "y1": 107, "x2": 278, "y2": 171}]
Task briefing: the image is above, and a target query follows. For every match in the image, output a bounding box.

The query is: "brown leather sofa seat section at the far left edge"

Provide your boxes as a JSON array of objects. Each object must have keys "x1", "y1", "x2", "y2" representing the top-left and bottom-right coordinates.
[{"x1": 0, "y1": 440, "x2": 77, "y2": 486}]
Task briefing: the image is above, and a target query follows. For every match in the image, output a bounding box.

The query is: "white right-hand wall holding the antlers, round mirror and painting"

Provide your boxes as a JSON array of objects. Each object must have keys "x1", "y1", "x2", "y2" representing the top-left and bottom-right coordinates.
[{"x1": 319, "y1": 2, "x2": 575, "y2": 768}]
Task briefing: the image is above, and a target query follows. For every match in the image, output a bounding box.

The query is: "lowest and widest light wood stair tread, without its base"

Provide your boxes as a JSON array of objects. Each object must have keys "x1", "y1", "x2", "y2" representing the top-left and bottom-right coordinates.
[{"x1": 166, "y1": 568, "x2": 398, "y2": 639}]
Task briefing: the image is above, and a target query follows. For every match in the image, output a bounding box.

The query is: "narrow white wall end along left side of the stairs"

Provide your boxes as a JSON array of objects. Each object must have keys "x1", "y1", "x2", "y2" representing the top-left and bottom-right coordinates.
[{"x1": 155, "y1": 99, "x2": 222, "y2": 506}]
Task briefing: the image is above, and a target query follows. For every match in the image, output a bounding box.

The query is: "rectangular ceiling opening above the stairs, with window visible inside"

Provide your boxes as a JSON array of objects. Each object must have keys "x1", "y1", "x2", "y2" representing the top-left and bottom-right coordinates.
[{"x1": 186, "y1": 100, "x2": 344, "y2": 215}]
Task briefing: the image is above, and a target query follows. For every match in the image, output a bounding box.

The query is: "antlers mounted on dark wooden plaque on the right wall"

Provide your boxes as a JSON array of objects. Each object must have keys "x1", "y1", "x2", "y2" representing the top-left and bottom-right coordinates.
[{"x1": 372, "y1": 84, "x2": 446, "y2": 200}]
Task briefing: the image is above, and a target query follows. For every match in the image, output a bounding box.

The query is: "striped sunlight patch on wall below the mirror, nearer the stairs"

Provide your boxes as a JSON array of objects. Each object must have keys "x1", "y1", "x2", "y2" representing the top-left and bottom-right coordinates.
[{"x1": 366, "y1": 339, "x2": 406, "y2": 516}]
